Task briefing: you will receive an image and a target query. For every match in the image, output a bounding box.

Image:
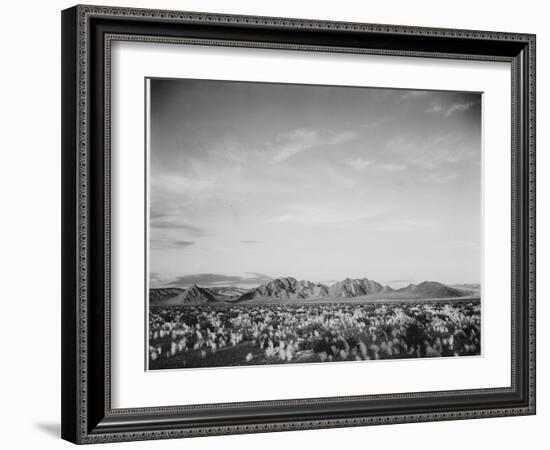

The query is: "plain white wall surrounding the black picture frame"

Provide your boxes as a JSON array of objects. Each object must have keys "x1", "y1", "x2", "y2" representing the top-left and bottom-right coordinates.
[{"x1": 0, "y1": 0, "x2": 550, "y2": 450}]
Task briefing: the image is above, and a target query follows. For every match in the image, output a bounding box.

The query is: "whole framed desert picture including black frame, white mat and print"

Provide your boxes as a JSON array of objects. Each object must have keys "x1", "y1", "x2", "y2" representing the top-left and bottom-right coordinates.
[{"x1": 62, "y1": 6, "x2": 535, "y2": 444}]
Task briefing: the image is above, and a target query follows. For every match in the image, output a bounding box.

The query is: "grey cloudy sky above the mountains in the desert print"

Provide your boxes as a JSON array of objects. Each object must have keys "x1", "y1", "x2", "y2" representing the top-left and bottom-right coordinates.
[{"x1": 149, "y1": 79, "x2": 481, "y2": 287}]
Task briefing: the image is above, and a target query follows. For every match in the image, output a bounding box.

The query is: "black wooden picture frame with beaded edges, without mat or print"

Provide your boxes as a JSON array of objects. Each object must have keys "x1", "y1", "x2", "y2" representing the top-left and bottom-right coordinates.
[{"x1": 62, "y1": 6, "x2": 535, "y2": 443}]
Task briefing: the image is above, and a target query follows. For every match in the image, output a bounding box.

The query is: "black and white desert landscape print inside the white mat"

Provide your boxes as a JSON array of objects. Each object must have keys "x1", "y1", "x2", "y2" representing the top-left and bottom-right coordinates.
[{"x1": 146, "y1": 78, "x2": 482, "y2": 370}]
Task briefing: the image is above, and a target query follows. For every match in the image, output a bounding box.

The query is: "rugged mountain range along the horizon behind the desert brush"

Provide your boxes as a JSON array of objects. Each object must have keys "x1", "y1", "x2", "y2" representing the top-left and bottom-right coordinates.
[{"x1": 149, "y1": 277, "x2": 472, "y2": 305}]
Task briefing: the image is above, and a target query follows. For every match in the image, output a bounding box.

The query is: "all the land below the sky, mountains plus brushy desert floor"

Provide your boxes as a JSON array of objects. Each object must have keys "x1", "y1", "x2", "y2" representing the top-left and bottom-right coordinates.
[{"x1": 148, "y1": 278, "x2": 481, "y2": 370}]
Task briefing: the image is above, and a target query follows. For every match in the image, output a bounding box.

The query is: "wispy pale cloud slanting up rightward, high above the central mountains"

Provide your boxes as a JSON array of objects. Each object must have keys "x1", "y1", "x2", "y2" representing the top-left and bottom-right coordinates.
[{"x1": 270, "y1": 128, "x2": 357, "y2": 164}]
